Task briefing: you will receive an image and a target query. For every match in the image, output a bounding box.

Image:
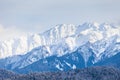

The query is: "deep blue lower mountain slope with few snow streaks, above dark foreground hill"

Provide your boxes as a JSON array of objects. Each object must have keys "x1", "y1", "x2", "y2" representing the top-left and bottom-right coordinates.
[{"x1": 14, "y1": 44, "x2": 120, "y2": 73}]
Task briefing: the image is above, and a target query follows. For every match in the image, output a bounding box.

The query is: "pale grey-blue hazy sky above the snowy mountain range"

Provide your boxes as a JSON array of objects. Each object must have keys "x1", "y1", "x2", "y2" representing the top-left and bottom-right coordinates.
[{"x1": 0, "y1": 0, "x2": 120, "y2": 40}]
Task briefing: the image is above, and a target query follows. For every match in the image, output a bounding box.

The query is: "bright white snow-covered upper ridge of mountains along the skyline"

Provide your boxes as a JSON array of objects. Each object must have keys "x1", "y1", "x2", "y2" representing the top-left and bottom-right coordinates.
[{"x1": 0, "y1": 22, "x2": 120, "y2": 58}]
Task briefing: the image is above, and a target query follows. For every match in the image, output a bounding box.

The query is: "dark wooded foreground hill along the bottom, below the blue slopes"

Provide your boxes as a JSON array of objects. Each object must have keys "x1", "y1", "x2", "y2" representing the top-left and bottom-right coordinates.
[{"x1": 0, "y1": 67, "x2": 120, "y2": 80}]
